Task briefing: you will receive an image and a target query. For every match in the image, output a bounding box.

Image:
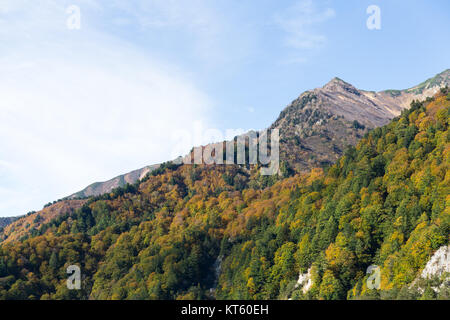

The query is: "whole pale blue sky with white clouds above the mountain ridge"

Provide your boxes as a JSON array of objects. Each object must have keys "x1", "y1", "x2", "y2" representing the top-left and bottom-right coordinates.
[{"x1": 0, "y1": 0, "x2": 450, "y2": 216}]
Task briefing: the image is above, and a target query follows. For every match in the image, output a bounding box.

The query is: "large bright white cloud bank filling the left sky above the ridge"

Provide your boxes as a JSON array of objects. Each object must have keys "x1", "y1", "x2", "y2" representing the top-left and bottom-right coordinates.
[{"x1": 0, "y1": 0, "x2": 212, "y2": 216}]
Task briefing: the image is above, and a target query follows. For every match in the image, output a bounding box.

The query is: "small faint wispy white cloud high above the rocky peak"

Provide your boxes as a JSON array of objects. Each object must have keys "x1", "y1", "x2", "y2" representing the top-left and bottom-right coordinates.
[{"x1": 275, "y1": 0, "x2": 336, "y2": 49}]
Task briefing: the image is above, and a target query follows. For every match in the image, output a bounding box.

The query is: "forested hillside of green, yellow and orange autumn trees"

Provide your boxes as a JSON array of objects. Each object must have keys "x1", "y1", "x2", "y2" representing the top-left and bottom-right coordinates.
[{"x1": 0, "y1": 90, "x2": 450, "y2": 299}]
